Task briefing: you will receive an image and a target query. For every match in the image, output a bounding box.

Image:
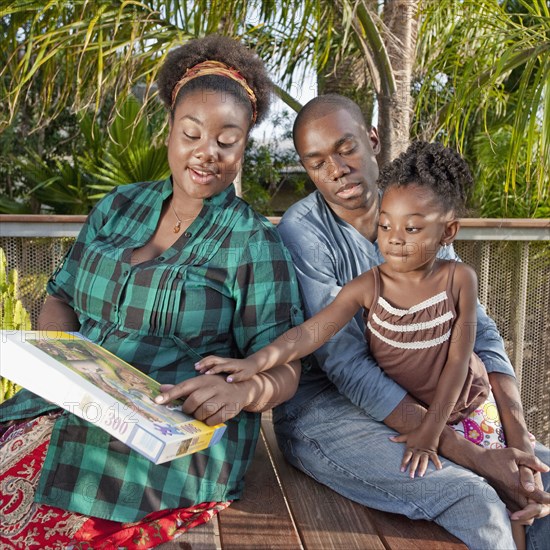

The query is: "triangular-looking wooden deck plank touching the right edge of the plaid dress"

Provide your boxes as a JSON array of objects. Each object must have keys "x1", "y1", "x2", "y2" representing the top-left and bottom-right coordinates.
[{"x1": 218, "y1": 437, "x2": 302, "y2": 550}]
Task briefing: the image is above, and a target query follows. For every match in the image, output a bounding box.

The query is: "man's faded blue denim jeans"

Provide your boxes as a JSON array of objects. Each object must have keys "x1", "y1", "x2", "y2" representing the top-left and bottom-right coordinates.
[{"x1": 274, "y1": 389, "x2": 550, "y2": 550}]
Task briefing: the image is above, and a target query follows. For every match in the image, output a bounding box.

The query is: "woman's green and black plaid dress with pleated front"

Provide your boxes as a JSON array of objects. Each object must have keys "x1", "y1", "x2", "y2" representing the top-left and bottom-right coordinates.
[{"x1": 0, "y1": 178, "x2": 302, "y2": 522}]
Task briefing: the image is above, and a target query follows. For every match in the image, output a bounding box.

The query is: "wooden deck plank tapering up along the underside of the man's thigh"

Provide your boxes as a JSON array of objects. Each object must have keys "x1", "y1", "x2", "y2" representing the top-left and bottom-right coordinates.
[{"x1": 262, "y1": 413, "x2": 385, "y2": 550}]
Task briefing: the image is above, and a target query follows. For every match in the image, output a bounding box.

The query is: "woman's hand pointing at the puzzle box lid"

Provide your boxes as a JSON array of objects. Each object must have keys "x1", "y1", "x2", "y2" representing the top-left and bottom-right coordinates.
[{"x1": 155, "y1": 376, "x2": 249, "y2": 426}]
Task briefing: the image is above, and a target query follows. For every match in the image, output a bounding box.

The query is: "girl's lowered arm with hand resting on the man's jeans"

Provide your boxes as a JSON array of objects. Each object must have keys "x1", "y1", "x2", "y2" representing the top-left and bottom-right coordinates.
[{"x1": 393, "y1": 264, "x2": 477, "y2": 477}]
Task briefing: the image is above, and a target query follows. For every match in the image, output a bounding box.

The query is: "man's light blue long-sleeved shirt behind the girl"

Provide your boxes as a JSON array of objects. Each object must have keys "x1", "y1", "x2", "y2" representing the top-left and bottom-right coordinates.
[{"x1": 278, "y1": 191, "x2": 514, "y2": 421}]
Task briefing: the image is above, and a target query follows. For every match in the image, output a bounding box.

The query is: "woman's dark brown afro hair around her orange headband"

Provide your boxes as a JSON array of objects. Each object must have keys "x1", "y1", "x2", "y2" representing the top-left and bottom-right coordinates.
[{"x1": 157, "y1": 34, "x2": 272, "y2": 126}]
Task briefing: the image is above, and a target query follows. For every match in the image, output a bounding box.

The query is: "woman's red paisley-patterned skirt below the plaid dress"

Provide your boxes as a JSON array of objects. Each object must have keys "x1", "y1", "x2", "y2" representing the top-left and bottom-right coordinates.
[{"x1": 0, "y1": 416, "x2": 230, "y2": 550}]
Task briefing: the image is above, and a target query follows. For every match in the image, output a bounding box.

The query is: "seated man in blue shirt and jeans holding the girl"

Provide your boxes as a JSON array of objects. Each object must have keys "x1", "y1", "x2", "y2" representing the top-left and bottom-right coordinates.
[{"x1": 275, "y1": 94, "x2": 550, "y2": 550}]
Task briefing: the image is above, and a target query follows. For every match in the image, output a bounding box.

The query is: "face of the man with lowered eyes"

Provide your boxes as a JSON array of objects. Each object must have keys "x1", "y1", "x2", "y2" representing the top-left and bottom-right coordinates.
[{"x1": 294, "y1": 109, "x2": 379, "y2": 218}]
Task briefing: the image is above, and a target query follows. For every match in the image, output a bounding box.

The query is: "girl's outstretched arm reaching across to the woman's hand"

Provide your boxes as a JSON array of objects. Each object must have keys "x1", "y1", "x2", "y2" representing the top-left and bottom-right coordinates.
[{"x1": 195, "y1": 271, "x2": 374, "y2": 382}]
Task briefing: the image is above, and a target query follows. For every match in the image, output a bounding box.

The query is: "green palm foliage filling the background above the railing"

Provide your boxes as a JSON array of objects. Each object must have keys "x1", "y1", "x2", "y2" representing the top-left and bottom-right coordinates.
[{"x1": 0, "y1": 0, "x2": 550, "y2": 216}]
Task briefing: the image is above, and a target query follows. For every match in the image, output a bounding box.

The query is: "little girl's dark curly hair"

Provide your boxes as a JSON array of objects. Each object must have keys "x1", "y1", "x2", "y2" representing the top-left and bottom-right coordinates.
[{"x1": 378, "y1": 141, "x2": 474, "y2": 216}]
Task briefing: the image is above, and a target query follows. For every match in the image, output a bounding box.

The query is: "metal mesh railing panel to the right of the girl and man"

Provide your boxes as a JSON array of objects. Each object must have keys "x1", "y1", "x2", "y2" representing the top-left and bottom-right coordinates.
[{"x1": 456, "y1": 241, "x2": 550, "y2": 445}]
